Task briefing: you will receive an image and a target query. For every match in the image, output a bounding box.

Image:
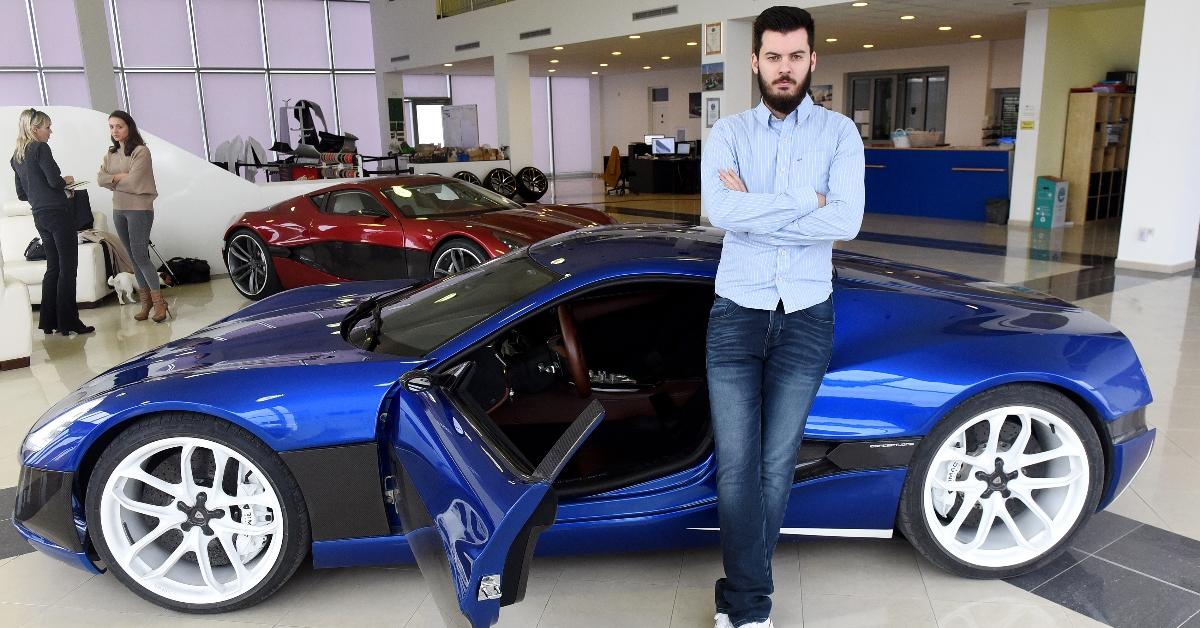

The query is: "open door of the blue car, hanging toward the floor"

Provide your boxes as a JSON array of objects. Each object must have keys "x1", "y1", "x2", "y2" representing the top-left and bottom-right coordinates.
[{"x1": 388, "y1": 363, "x2": 604, "y2": 628}]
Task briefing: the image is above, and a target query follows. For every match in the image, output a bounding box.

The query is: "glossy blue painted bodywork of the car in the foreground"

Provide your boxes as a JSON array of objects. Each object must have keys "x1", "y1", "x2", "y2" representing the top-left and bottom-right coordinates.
[{"x1": 25, "y1": 226, "x2": 1153, "y2": 600}]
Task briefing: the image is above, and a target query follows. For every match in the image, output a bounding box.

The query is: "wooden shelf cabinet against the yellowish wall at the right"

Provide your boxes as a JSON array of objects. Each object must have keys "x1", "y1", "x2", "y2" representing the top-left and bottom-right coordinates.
[{"x1": 1062, "y1": 92, "x2": 1134, "y2": 223}]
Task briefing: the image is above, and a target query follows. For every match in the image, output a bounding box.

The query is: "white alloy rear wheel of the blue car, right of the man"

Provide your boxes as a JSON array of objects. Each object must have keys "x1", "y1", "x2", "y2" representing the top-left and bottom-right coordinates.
[{"x1": 920, "y1": 405, "x2": 1103, "y2": 568}]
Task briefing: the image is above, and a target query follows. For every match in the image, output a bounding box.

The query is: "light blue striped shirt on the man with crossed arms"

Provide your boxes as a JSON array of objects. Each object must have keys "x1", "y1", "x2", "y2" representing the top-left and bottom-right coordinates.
[{"x1": 700, "y1": 96, "x2": 865, "y2": 312}]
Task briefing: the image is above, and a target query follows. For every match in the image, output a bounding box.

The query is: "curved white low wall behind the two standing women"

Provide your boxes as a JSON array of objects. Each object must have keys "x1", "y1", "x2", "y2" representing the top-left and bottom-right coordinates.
[{"x1": 0, "y1": 107, "x2": 338, "y2": 273}]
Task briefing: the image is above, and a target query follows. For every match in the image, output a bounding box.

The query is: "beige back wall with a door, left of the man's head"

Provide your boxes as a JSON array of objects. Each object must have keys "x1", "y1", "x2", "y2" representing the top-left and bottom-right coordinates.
[{"x1": 596, "y1": 67, "x2": 703, "y2": 155}]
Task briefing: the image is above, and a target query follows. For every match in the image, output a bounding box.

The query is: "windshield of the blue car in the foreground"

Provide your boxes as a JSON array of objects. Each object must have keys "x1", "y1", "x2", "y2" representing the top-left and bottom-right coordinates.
[{"x1": 348, "y1": 252, "x2": 559, "y2": 357}]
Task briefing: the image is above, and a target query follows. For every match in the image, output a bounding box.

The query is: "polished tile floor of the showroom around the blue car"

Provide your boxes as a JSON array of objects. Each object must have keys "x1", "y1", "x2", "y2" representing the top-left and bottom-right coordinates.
[{"x1": 0, "y1": 179, "x2": 1200, "y2": 628}]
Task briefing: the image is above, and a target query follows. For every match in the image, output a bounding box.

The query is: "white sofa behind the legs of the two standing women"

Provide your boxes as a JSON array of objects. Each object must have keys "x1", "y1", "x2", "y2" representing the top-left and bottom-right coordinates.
[{"x1": 0, "y1": 201, "x2": 113, "y2": 307}]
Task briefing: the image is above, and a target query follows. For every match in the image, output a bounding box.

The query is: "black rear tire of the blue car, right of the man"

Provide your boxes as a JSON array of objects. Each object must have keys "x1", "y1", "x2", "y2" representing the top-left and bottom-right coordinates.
[{"x1": 896, "y1": 384, "x2": 1105, "y2": 579}]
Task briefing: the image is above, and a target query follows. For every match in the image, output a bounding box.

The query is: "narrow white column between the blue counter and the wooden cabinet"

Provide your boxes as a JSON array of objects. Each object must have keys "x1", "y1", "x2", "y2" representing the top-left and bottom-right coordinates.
[{"x1": 1008, "y1": 8, "x2": 1050, "y2": 226}]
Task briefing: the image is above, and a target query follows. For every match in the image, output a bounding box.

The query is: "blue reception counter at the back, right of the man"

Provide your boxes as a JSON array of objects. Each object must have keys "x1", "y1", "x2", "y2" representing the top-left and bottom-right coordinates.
[{"x1": 866, "y1": 148, "x2": 1013, "y2": 222}]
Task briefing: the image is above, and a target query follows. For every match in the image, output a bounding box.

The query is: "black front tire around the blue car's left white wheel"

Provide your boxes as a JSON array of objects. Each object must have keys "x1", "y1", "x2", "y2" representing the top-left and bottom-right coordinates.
[{"x1": 84, "y1": 412, "x2": 311, "y2": 614}]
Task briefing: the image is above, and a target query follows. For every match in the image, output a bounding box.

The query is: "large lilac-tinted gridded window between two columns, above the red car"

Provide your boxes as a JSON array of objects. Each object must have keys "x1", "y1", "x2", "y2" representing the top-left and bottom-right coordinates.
[{"x1": 109, "y1": 0, "x2": 382, "y2": 155}]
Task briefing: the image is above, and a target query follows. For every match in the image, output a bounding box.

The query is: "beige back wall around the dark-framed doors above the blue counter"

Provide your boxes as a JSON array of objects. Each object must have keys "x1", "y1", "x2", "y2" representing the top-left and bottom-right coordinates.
[{"x1": 812, "y1": 41, "x2": 993, "y2": 146}]
